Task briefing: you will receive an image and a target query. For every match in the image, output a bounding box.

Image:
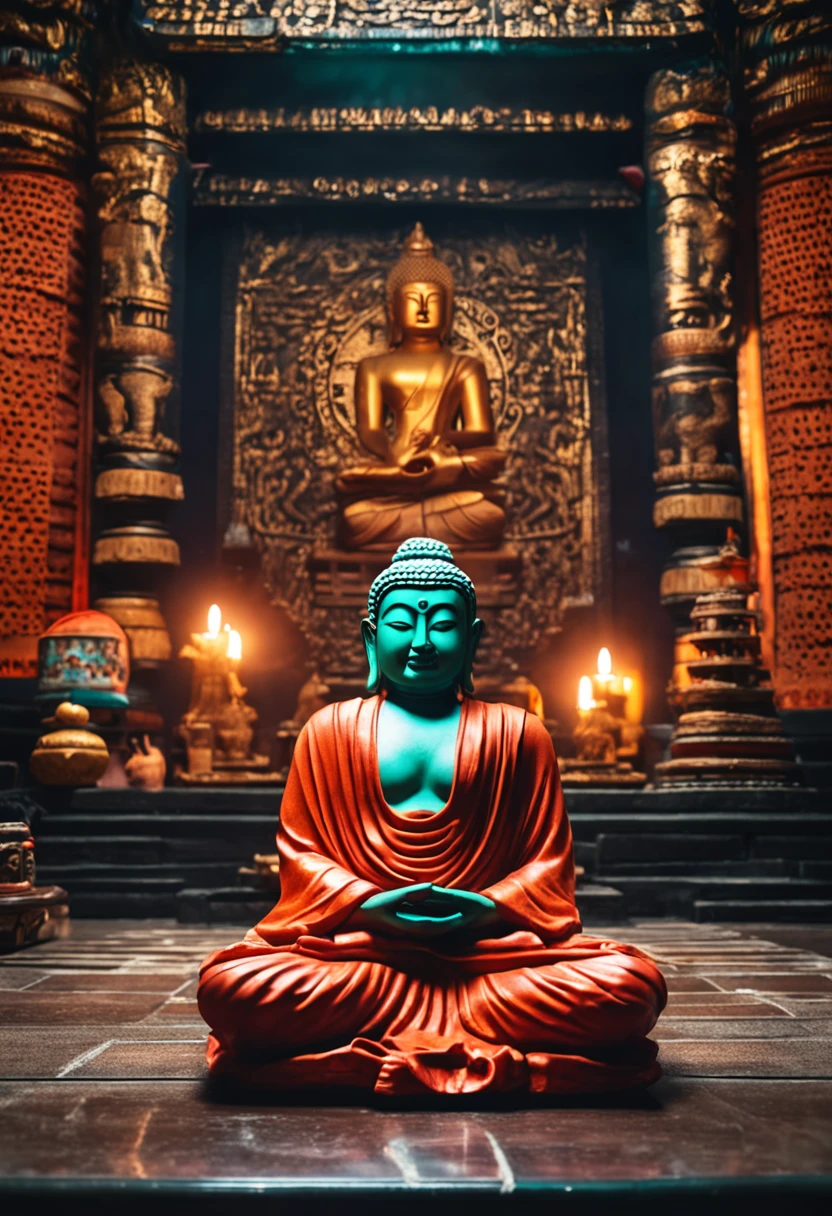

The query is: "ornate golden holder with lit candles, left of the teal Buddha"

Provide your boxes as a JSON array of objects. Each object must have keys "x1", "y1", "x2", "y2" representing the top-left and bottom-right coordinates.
[{"x1": 174, "y1": 604, "x2": 281, "y2": 786}]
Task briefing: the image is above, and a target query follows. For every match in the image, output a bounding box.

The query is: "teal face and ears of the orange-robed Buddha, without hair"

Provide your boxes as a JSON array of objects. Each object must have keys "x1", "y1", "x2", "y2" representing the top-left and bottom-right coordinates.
[{"x1": 362, "y1": 586, "x2": 482, "y2": 696}]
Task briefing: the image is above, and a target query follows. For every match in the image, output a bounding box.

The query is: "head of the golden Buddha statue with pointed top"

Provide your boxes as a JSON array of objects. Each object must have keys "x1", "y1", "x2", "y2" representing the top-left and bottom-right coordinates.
[{"x1": 387, "y1": 224, "x2": 454, "y2": 347}]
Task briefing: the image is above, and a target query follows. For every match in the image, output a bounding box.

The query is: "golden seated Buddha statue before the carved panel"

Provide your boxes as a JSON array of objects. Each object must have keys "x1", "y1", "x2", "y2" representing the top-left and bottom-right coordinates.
[{"x1": 336, "y1": 224, "x2": 506, "y2": 552}]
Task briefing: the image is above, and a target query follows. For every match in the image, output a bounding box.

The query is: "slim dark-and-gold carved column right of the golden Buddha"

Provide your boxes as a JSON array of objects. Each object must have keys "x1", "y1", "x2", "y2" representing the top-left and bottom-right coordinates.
[{"x1": 646, "y1": 61, "x2": 746, "y2": 672}]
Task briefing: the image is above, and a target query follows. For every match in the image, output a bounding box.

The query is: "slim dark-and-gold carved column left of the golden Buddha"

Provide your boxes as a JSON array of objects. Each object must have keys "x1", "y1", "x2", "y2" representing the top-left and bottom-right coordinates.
[{"x1": 92, "y1": 58, "x2": 186, "y2": 728}]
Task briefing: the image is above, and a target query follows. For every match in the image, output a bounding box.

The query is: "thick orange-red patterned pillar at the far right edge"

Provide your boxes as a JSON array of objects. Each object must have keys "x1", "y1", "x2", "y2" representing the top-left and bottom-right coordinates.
[{"x1": 738, "y1": 0, "x2": 832, "y2": 715}]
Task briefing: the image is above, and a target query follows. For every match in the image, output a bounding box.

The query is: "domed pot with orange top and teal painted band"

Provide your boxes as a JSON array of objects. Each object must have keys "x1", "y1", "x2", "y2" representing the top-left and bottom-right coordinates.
[{"x1": 38, "y1": 608, "x2": 130, "y2": 709}]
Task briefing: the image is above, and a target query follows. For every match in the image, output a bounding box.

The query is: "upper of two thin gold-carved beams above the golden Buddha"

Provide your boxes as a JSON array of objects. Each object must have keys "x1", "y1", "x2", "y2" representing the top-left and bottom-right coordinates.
[{"x1": 193, "y1": 106, "x2": 633, "y2": 135}]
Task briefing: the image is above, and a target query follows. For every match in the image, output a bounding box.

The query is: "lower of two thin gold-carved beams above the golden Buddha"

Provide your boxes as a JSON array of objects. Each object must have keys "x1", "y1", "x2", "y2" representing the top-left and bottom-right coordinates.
[{"x1": 193, "y1": 173, "x2": 639, "y2": 210}]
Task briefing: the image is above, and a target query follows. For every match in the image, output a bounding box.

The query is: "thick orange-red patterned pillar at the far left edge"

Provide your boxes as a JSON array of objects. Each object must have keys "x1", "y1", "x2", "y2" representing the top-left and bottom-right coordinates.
[{"x1": 0, "y1": 0, "x2": 91, "y2": 677}]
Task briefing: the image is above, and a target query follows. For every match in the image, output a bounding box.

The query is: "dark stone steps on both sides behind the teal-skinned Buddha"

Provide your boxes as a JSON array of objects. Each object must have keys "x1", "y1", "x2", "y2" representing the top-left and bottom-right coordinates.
[{"x1": 24, "y1": 788, "x2": 832, "y2": 927}]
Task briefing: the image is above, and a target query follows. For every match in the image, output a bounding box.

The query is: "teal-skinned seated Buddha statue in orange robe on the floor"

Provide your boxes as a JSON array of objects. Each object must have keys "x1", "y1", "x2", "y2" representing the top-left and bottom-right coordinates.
[{"x1": 198, "y1": 539, "x2": 667, "y2": 1094}]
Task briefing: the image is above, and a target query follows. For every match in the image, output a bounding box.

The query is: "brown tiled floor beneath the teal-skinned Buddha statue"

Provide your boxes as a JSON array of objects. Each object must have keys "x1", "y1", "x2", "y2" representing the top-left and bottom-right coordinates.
[{"x1": 0, "y1": 919, "x2": 832, "y2": 1216}]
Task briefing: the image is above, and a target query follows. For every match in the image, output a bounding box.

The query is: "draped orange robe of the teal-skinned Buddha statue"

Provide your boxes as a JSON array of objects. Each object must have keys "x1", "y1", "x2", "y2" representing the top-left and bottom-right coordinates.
[{"x1": 198, "y1": 697, "x2": 667, "y2": 1094}]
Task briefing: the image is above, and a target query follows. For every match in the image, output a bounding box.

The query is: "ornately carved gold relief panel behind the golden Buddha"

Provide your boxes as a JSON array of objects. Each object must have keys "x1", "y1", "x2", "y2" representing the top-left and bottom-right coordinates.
[{"x1": 231, "y1": 229, "x2": 601, "y2": 672}]
